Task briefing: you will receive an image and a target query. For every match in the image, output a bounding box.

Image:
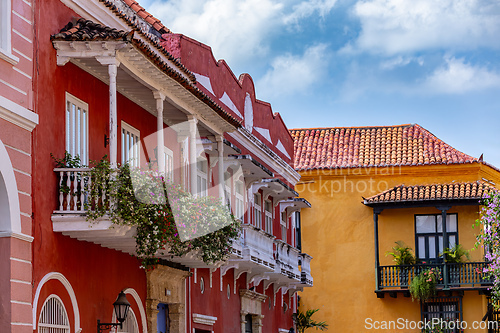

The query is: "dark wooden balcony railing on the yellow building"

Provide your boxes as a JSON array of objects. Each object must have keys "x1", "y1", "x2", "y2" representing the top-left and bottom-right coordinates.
[{"x1": 378, "y1": 262, "x2": 491, "y2": 290}]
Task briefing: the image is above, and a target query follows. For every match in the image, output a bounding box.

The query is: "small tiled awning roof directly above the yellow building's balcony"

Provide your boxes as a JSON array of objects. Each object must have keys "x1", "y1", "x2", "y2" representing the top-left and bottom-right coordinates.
[{"x1": 364, "y1": 181, "x2": 498, "y2": 204}]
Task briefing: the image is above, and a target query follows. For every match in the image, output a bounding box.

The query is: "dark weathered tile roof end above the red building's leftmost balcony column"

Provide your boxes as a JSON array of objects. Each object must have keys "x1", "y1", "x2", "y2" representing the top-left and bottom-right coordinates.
[{"x1": 51, "y1": 18, "x2": 134, "y2": 41}]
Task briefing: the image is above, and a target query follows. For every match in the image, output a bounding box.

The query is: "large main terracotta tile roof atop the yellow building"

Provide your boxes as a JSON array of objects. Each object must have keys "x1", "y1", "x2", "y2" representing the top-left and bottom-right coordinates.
[{"x1": 290, "y1": 124, "x2": 478, "y2": 170}]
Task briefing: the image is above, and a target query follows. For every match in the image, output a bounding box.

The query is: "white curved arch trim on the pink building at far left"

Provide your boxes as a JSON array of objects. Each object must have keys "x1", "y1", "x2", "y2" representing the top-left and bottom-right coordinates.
[{"x1": 0, "y1": 140, "x2": 22, "y2": 232}]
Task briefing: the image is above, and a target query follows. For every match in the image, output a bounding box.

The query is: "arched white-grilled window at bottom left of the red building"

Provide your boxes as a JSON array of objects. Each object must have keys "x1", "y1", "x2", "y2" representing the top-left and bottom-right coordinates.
[{"x1": 38, "y1": 295, "x2": 70, "y2": 333}]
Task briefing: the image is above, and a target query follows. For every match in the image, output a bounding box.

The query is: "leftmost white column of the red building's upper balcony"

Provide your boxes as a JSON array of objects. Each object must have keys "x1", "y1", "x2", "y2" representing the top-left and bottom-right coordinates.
[{"x1": 96, "y1": 57, "x2": 120, "y2": 168}]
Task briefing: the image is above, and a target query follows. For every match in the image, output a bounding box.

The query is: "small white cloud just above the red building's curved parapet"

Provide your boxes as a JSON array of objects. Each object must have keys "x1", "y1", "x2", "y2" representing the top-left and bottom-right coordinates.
[{"x1": 257, "y1": 44, "x2": 328, "y2": 98}]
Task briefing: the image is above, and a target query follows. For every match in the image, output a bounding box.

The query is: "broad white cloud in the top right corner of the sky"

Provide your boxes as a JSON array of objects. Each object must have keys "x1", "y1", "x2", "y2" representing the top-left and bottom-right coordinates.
[{"x1": 343, "y1": 0, "x2": 500, "y2": 55}]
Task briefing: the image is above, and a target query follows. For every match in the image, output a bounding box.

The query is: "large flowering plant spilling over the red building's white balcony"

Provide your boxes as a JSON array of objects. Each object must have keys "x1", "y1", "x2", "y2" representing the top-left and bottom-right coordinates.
[{"x1": 85, "y1": 159, "x2": 241, "y2": 269}]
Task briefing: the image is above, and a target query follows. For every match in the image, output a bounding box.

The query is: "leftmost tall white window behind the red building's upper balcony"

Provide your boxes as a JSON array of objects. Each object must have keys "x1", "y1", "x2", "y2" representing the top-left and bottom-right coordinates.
[{"x1": 66, "y1": 93, "x2": 89, "y2": 165}]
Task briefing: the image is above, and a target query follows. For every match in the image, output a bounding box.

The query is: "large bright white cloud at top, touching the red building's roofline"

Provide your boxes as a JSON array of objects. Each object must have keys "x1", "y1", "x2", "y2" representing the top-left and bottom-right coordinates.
[{"x1": 145, "y1": 0, "x2": 337, "y2": 66}]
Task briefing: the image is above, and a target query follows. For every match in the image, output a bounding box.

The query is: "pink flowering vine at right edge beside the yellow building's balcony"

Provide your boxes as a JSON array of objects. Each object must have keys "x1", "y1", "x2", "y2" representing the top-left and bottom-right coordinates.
[{"x1": 475, "y1": 192, "x2": 500, "y2": 307}]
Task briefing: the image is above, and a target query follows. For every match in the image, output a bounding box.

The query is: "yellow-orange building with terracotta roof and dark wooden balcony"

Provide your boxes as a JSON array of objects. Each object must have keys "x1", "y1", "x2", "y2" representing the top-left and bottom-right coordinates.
[{"x1": 291, "y1": 125, "x2": 500, "y2": 333}]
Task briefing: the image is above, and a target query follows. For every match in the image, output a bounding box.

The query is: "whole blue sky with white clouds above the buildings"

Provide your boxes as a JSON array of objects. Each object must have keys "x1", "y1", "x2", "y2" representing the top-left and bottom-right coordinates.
[{"x1": 140, "y1": 0, "x2": 500, "y2": 167}]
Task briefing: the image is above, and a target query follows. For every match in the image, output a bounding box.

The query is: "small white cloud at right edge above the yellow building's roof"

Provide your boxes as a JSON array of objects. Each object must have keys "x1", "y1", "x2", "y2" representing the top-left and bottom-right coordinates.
[{"x1": 420, "y1": 58, "x2": 500, "y2": 94}]
